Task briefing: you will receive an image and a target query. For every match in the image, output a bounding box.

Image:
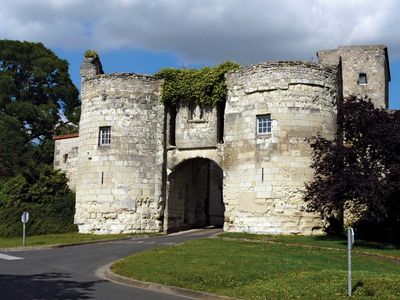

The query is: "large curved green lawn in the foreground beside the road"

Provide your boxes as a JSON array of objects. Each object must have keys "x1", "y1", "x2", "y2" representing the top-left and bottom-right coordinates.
[{"x1": 112, "y1": 239, "x2": 400, "y2": 299}]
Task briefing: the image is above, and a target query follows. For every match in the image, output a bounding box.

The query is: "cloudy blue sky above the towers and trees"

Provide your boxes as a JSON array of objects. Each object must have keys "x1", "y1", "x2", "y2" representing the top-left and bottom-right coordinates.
[{"x1": 0, "y1": 0, "x2": 400, "y2": 109}]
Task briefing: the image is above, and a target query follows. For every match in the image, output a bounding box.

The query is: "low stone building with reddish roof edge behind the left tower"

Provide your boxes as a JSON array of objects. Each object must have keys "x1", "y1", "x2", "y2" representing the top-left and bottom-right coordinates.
[{"x1": 53, "y1": 134, "x2": 79, "y2": 191}]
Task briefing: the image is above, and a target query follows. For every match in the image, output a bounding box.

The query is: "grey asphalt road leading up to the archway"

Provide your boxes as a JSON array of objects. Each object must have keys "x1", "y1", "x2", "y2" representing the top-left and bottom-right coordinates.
[{"x1": 0, "y1": 229, "x2": 219, "y2": 300}]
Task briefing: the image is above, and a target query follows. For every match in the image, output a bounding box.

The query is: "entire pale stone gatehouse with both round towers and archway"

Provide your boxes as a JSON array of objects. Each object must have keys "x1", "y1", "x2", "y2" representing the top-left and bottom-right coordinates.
[{"x1": 54, "y1": 46, "x2": 390, "y2": 234}]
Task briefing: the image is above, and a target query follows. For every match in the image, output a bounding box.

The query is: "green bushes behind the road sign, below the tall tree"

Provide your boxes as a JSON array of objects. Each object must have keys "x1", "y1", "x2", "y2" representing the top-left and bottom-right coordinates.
[{"x1": 0, "y1": 169, "x2": 76, "y2": 237}]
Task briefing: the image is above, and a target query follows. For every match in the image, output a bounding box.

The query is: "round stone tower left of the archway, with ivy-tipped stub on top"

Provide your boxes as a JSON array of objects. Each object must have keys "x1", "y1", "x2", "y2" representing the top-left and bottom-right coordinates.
[{"x1": 75, "y1": 57, "x2": 165, "y2": 233}]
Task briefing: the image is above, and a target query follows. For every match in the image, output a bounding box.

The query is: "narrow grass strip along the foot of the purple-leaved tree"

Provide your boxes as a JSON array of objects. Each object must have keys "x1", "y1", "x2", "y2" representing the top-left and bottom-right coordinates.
[{"x1": 218, "y1": 232, "x2": 400, "y2": 259}]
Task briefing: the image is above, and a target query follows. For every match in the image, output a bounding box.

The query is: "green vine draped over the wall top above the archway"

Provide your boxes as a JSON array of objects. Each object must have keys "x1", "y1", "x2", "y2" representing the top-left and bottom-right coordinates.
[{"x1": 155, "y1": 61, "x2": 240, "y2": 106}]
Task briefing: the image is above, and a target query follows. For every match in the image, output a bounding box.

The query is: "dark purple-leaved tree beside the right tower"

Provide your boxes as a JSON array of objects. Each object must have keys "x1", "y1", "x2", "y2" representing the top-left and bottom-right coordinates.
[{"x1": 305, "y1": 97, "x2": 400, "y2": 237}]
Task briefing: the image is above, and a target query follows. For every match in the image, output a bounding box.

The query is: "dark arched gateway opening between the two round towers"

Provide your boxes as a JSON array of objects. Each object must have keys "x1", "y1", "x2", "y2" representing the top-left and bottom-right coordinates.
[{"x1": 167, "y1": 158, "x2": 225, "y2": 232}]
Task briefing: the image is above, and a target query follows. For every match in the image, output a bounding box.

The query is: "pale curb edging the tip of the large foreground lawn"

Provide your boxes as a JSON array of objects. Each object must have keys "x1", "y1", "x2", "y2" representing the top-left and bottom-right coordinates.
[{"x1": 101, "y1": 261, "x2": 237, "y2": 300}]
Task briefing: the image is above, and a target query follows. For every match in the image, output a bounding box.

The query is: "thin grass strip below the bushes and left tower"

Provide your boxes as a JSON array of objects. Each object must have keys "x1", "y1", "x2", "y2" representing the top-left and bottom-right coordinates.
[{"x1": 0, "y1": 232, "x2": 152, "y2": 248}]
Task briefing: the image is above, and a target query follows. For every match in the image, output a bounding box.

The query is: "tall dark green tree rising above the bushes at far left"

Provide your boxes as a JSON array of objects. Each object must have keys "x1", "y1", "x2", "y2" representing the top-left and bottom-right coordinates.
[{"x1": 0, "y1": 40, "x2": 80, "y2": 177}]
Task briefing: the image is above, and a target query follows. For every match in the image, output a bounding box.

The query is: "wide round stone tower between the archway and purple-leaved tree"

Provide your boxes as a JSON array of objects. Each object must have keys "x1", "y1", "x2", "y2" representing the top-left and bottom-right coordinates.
[{"x1": 223, "y1": 62, "x2": 338, "y2": 234}]
